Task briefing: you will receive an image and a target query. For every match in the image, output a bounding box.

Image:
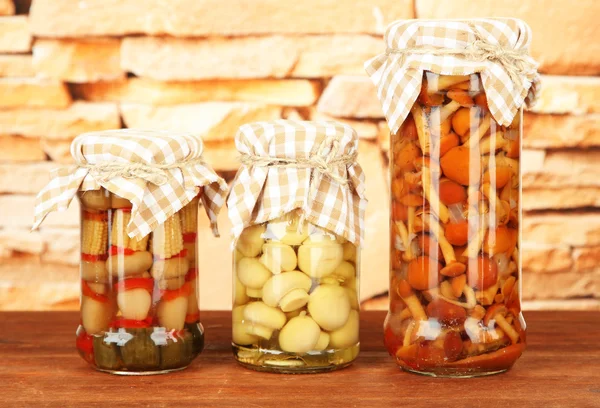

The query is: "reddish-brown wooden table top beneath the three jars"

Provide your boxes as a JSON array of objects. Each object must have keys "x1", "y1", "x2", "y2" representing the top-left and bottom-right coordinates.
[{"x1": 0, "y1": 312, "x2": 600, "y2": 408}]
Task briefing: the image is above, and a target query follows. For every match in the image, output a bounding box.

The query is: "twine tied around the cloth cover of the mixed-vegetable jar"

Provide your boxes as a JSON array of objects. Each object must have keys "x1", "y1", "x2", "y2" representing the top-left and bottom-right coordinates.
[{"x1": 78, "y1": 157, "x2": 206, "y2": 186}]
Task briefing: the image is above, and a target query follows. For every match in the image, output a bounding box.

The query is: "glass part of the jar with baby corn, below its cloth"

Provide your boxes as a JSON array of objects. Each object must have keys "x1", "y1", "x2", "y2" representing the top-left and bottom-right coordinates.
[{"x1": 76, "y1": 188, "x2": 204, "y2": 374}]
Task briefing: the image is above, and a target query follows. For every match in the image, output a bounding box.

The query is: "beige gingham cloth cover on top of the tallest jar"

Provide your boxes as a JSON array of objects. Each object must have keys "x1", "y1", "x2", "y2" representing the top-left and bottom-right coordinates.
[{"x1": 365, "y1": 19, "x2": 540, "y2": 132}]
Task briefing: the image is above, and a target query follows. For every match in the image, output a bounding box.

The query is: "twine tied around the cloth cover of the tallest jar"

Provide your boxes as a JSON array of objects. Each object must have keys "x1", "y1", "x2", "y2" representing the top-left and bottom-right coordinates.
[{"x1": 386, "y1": 23, "x2": 538, "y2": 88}]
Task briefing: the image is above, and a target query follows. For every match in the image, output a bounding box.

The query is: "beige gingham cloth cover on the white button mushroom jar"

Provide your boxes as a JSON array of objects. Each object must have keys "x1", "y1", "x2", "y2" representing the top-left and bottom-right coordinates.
[{"x1": 227, "y1": 120, "x2": 367, "y2": 245}]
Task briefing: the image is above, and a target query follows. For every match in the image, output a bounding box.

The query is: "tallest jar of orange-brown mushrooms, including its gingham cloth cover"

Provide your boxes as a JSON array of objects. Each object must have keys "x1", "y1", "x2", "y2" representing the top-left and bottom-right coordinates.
[{"x1": 367, "y1": 19, "x2": 538, "y2": 377}]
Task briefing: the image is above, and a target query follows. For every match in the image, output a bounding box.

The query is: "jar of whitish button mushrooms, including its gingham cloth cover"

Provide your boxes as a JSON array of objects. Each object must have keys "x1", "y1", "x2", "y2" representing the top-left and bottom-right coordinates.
[{"x1": 228, "y1": 121, "x2": 366, "y2": 373}]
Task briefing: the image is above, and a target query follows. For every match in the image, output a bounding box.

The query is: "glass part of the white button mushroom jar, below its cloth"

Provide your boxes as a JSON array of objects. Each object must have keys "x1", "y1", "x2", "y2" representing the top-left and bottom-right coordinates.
[{"x1": 232, "y1": 211, "x2": 360, "y2": 373}]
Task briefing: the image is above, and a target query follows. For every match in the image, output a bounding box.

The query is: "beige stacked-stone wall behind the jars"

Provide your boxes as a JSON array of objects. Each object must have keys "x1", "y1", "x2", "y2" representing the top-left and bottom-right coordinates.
[{"x1": 0, "y1": 0, "x2": 600, "y2": 310}]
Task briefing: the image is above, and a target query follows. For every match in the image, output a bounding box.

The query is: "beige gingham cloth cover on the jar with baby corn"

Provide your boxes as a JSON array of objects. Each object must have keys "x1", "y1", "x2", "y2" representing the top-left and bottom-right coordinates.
[{"x1": 33, "y1": 129, "x2": 227, "y2": 238}]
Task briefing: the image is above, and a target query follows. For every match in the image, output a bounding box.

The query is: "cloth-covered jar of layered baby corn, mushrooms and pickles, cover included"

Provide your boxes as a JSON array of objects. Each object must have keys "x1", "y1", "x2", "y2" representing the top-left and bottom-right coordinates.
[{"x1": 35, "y1": 130, "x2": 226, "y2": 375}]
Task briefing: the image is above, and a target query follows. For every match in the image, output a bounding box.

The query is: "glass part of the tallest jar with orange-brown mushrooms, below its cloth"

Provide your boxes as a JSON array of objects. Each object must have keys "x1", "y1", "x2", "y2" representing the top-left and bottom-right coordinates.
[{"x1": 385, "y1": 72, "x2": 525, "y2": 377}]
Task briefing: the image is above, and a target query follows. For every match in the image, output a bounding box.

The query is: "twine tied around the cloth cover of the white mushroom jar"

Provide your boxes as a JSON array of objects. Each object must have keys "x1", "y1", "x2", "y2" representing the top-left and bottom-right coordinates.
[{"x1": 240, "y1": 137, "x2": 357, "y2": 186}]
